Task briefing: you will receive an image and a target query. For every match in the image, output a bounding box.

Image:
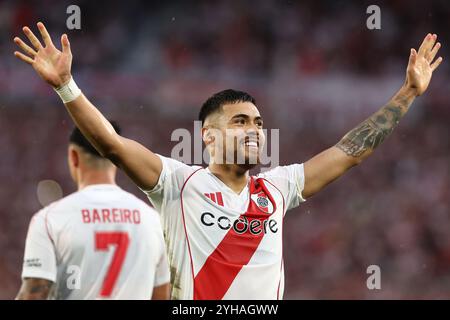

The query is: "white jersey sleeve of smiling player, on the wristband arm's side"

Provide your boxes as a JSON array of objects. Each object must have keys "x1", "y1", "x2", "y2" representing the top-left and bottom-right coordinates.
[{"x1": 141, "y1": 154, "x2": 198, "y2": 213}]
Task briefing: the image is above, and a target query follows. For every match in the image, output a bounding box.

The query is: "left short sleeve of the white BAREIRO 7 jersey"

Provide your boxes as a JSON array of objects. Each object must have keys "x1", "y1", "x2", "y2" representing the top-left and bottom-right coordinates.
[{"x1": 22, "y1": 211, "x2": 57, "y2": 282}]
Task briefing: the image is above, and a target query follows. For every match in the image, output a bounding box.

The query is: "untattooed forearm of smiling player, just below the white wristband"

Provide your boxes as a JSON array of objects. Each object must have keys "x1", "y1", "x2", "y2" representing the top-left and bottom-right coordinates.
[{"x1": 65, "y1": 94, "x2": 121, "y2": 157}]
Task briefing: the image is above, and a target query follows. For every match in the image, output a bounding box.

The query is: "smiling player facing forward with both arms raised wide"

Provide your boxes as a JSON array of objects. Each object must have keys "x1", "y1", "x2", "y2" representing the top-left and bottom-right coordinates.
[{"x1": 14, "y1": 23, "x2": 442, "y2": 299}]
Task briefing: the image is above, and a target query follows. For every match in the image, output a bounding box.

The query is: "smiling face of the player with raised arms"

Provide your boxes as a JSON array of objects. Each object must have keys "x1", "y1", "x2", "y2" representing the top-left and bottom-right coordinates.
[{"x1": 202, "y1": 102, "x2": 265, "y2": 169}]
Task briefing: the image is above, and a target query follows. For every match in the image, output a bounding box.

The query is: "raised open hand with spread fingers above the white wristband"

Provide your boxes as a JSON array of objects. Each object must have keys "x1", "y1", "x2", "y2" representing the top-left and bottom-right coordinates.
[{"x1": 14, "y1": 22, "x2": 72, "y2": 88}]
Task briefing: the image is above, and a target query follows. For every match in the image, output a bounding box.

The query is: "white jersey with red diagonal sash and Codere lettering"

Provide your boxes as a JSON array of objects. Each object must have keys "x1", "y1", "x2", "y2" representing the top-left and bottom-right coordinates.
[{"x1": 144, "y1": 156, "x2": 304, "y2": 299}]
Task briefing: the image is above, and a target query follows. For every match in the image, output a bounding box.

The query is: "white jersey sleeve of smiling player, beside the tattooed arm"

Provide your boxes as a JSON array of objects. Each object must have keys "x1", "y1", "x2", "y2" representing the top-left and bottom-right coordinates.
[{"x1": 258, "y1": 163, "x2": 306, "y2": 210}]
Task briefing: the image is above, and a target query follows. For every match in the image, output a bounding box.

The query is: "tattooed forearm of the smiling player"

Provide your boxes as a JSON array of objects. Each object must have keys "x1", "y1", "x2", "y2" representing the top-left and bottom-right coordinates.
[{"x1": 336, "y1": 86, "x2": 416, "y2": 164}]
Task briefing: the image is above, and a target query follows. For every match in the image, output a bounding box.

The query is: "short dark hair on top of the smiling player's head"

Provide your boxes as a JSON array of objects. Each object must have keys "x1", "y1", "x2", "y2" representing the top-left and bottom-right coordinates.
[{"x1": 198, "y1": 89, "x2": 256, "y2": 125}]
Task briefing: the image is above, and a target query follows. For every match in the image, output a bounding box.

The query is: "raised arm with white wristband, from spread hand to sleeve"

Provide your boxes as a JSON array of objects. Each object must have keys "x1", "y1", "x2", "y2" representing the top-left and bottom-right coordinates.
[{"x1": 14, "y1": 22, "x2": 162, "y2": 190}]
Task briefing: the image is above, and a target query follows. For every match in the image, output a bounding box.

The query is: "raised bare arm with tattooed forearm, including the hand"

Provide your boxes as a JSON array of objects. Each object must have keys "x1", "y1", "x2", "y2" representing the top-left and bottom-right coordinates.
[{"x1": 303, "y1": 34, "x2": 442, "y2": 198}]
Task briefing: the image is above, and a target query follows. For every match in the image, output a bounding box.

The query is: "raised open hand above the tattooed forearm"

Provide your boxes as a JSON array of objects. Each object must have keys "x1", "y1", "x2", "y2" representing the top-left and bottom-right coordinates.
[{"x1": 405, "y1": 33, "x2": 442, "y2": 96}]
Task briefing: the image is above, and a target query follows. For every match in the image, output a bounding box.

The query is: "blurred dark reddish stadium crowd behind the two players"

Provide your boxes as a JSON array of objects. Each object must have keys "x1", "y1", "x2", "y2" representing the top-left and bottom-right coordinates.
[{"x1": 0, "y1": 0, "x2": 450, "y2": 299}]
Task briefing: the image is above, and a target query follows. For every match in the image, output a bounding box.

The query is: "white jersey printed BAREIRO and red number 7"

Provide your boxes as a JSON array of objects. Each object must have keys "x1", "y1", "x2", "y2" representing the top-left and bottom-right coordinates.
[{"x1": 22, "y1": 184, "x2": 170, "y2": 299}]
